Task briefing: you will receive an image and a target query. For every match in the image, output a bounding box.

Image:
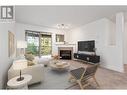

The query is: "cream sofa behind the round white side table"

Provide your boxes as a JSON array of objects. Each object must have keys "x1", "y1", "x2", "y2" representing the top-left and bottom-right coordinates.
[{"x1": 8, "y1": 59, "x2": 44, "y2": 85}]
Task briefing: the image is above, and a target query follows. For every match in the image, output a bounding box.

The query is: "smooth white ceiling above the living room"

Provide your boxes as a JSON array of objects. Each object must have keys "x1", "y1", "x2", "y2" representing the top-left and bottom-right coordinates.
[{"x1": 15, "y1": 6, "x2": 127, "y2": 29}]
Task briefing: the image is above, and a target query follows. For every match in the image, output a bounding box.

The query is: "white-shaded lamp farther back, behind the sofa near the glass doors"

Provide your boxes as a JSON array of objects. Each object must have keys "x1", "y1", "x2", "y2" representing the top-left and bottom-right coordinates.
[{"x1": 17, "y1": 41, "x2": 27, "y2": 56}]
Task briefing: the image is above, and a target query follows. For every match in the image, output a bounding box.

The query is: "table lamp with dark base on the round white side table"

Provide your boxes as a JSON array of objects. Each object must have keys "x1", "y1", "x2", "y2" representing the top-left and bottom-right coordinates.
[{"x1": 13, "y1": 59, "x2": 27, "y2": 81}]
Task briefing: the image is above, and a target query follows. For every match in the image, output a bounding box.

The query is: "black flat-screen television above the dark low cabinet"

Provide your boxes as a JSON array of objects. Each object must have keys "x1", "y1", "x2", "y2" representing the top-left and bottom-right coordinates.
[{"x1": 78, "y1": 40, "x2": 95, "y2": 52}]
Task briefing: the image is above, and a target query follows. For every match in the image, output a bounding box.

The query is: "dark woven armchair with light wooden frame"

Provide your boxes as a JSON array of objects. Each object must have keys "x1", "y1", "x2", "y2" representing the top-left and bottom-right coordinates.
[{"x1": 69, "y1": 64, "x2": 99, "y2": 89}]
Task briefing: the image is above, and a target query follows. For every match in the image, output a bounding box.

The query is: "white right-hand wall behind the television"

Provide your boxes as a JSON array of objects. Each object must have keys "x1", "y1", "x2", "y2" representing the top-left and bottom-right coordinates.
[{"x1": 68, "y1": 18, "x2": 123, "y2": 72}]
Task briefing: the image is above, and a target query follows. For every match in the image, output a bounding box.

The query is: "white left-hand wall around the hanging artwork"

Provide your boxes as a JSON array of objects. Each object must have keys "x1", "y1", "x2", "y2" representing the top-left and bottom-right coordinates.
[{"x1": 0, "y1": 22, "x2": 15, "y2": 88}]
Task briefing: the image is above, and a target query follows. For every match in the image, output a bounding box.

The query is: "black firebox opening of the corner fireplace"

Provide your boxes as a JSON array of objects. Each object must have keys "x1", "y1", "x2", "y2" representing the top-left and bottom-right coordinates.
[{"x1": 60, "y1": 50, "x2": 72, "y2": 59}]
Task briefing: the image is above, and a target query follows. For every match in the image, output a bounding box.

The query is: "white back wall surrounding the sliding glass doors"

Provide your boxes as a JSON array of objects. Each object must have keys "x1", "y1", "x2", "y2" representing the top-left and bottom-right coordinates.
[{"x1": 16, "y1": 23, "x2": 66, "y2": 55}]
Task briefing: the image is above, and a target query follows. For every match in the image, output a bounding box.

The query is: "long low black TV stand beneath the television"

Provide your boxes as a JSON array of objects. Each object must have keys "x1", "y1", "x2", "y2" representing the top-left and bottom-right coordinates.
[{"x1": 74, "y1": 53, "x2": 100, "y2": 63}]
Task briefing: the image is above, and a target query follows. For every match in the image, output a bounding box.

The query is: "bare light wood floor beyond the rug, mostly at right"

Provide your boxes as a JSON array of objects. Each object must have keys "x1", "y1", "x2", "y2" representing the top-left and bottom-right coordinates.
[{"x1": 63, "y1": 60, "x2": 127, "y2": 89}]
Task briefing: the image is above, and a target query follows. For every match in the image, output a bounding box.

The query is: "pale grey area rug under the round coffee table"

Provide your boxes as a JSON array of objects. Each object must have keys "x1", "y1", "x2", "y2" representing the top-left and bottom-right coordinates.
[{"x1": 29, "y1": 67, "x2": 72, "y2": 89}]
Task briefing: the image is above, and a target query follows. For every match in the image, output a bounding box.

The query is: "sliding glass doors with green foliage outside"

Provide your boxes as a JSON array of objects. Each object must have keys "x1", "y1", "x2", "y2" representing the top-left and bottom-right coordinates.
[{"x1": 25, "y1": 30, "x2": 52, "y2": 57}]
